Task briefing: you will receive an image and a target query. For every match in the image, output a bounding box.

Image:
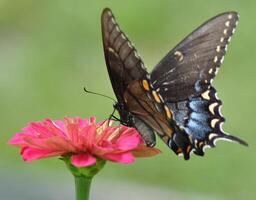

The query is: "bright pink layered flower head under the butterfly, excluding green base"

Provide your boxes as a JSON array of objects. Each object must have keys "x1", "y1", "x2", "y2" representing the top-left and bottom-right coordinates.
[{"x1": 9, "y1": 117, "x2": 160, "y2": 167}]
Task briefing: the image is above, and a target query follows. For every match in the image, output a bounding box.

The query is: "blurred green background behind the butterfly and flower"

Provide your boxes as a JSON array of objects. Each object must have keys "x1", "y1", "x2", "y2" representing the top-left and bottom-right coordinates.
[{"x1": 0, "y1": 0, "x2": 256, "y2": 200}]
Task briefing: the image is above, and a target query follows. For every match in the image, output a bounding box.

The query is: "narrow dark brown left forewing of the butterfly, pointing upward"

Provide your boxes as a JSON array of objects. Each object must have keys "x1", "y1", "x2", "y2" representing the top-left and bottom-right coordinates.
[{"x1": 101, "y1": 8, "x2": 147, "y2": 103}]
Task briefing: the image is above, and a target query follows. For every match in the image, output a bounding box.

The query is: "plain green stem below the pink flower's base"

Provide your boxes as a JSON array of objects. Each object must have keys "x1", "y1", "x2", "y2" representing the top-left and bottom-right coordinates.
[{"x1": 75, "y1": 176, "x2": 92, "y2": 200}]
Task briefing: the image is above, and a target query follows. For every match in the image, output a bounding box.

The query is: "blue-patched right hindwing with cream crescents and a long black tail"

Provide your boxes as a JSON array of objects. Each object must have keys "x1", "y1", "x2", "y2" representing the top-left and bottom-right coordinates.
[{"x1": 167, "y1": 87, "x2": 246, "y2": 155}]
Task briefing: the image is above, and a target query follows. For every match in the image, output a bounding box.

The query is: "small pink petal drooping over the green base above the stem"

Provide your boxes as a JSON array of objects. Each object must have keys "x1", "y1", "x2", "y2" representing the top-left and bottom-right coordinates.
[{"x1": 71, "y1": 153, "x2": 96, "y2": 167}]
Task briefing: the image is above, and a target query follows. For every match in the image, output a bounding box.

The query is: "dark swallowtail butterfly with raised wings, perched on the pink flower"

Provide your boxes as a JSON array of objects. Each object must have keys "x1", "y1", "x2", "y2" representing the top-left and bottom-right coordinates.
[{"x1": 101, "y1": 8, "x2": 247, "y2": 160}]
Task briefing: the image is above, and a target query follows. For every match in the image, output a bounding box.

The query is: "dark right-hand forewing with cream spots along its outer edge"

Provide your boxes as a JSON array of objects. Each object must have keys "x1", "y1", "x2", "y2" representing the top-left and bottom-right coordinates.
[{"x1": 151, "y1": 12, "x2": 238, "y2": 102}]
